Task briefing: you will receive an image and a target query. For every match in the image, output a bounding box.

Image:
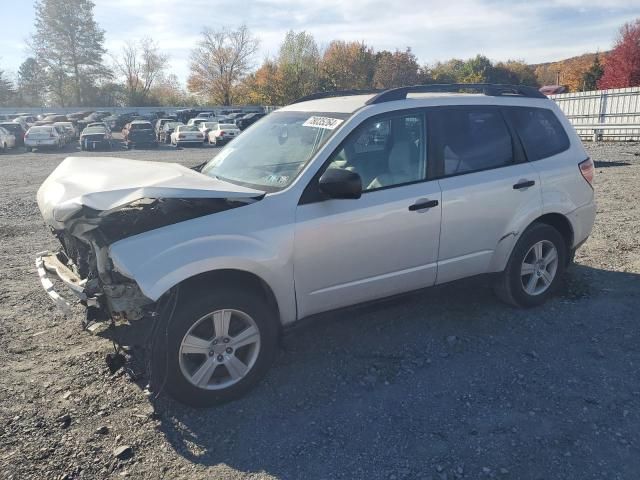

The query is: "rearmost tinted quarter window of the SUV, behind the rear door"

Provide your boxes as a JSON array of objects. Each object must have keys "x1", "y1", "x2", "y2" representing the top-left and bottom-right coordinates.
[{"x1": 508, "y1": 108, "x2": 569, "y2": 160}]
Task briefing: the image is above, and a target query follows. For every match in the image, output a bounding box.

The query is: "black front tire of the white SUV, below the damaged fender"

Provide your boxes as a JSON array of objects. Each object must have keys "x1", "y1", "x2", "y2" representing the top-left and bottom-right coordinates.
[{"x1": 152, "y1": 287, "x2": 279, "y2": 407}]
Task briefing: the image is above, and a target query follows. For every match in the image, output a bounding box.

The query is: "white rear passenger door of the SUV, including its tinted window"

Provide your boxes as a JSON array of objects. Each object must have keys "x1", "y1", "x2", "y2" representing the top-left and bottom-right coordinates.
[{"x1": 429, "y1": 106, "x2": 542, "y2": 283}]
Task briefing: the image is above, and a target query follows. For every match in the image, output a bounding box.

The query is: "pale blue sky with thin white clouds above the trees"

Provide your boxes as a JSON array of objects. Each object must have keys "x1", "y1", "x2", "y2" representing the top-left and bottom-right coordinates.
[{"x1": 0, "y1": 0, "x2": 640, "y2": 82}]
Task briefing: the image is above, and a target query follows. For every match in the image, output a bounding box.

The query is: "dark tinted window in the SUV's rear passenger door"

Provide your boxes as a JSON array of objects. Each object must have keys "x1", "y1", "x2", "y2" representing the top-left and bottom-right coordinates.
[{"x1": 434, "y1": 107, "x2": 514, "y2": 175}]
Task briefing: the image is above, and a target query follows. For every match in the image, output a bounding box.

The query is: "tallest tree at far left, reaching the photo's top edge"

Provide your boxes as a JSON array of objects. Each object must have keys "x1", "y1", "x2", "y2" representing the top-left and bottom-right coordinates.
[{"x1": 30, "y1": 0, "x2": 109, "y2": 105}]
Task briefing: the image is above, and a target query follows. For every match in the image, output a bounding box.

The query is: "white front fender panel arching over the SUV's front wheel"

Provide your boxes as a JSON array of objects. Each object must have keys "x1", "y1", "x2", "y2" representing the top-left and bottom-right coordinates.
[{"x1": 109, "y1": 207, "x2": 296, "y2": 323}]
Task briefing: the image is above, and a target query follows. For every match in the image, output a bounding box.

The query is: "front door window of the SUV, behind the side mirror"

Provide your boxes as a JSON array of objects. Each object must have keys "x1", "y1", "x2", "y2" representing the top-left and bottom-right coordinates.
[{"x1": 328, "y1": 114, "x2": 427, "y2": 192}]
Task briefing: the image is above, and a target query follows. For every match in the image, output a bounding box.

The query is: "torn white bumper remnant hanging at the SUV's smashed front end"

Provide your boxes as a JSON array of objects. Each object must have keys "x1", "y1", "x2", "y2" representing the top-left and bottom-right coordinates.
[{"x1": 36, "y1": 251, "x2": 99, "y2": 315}]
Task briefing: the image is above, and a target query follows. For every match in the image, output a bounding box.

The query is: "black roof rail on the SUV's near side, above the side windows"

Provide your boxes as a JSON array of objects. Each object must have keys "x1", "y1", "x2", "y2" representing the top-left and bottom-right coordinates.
[{"x1": 367, "y1": 83, "x2": 547, "y2": 105}]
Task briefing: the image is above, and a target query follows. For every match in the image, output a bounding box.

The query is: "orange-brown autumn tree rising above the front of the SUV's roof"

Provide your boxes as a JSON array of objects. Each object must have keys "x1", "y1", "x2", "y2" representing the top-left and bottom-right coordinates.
[{"x1": 320, "y1": 40, "x2": 376, "y2": 90}]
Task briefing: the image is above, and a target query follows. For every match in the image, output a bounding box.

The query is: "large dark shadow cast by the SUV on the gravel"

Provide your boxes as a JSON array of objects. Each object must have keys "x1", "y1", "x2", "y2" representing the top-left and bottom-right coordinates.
[{"x1": 144, "y1": 265, "x2": 640, "y2": 479}]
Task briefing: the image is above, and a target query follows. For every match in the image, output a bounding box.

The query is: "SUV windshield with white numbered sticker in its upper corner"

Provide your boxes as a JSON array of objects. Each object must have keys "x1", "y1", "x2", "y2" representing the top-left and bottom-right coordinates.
[{"x1": 202, "y1": 111, "x2": 348, "y2": 192}]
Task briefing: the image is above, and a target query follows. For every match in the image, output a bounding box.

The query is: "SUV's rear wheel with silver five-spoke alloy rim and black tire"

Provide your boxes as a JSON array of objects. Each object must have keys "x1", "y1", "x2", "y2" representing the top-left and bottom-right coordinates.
[{"x1": 494, "y1": 223, "x2": 567, "y2": 307}]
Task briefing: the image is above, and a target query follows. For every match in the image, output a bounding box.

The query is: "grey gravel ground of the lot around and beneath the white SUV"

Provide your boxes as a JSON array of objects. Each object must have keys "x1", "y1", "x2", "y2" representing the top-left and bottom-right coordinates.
[{"x1": 0, "y1": 143, "x2": 640, "y2": 480}]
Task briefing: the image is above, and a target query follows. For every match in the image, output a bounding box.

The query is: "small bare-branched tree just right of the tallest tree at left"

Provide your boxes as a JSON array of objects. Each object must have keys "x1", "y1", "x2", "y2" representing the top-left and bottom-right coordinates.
[{"x1": 114, "y1": 38, "x2": 169, "y2": 106}]
